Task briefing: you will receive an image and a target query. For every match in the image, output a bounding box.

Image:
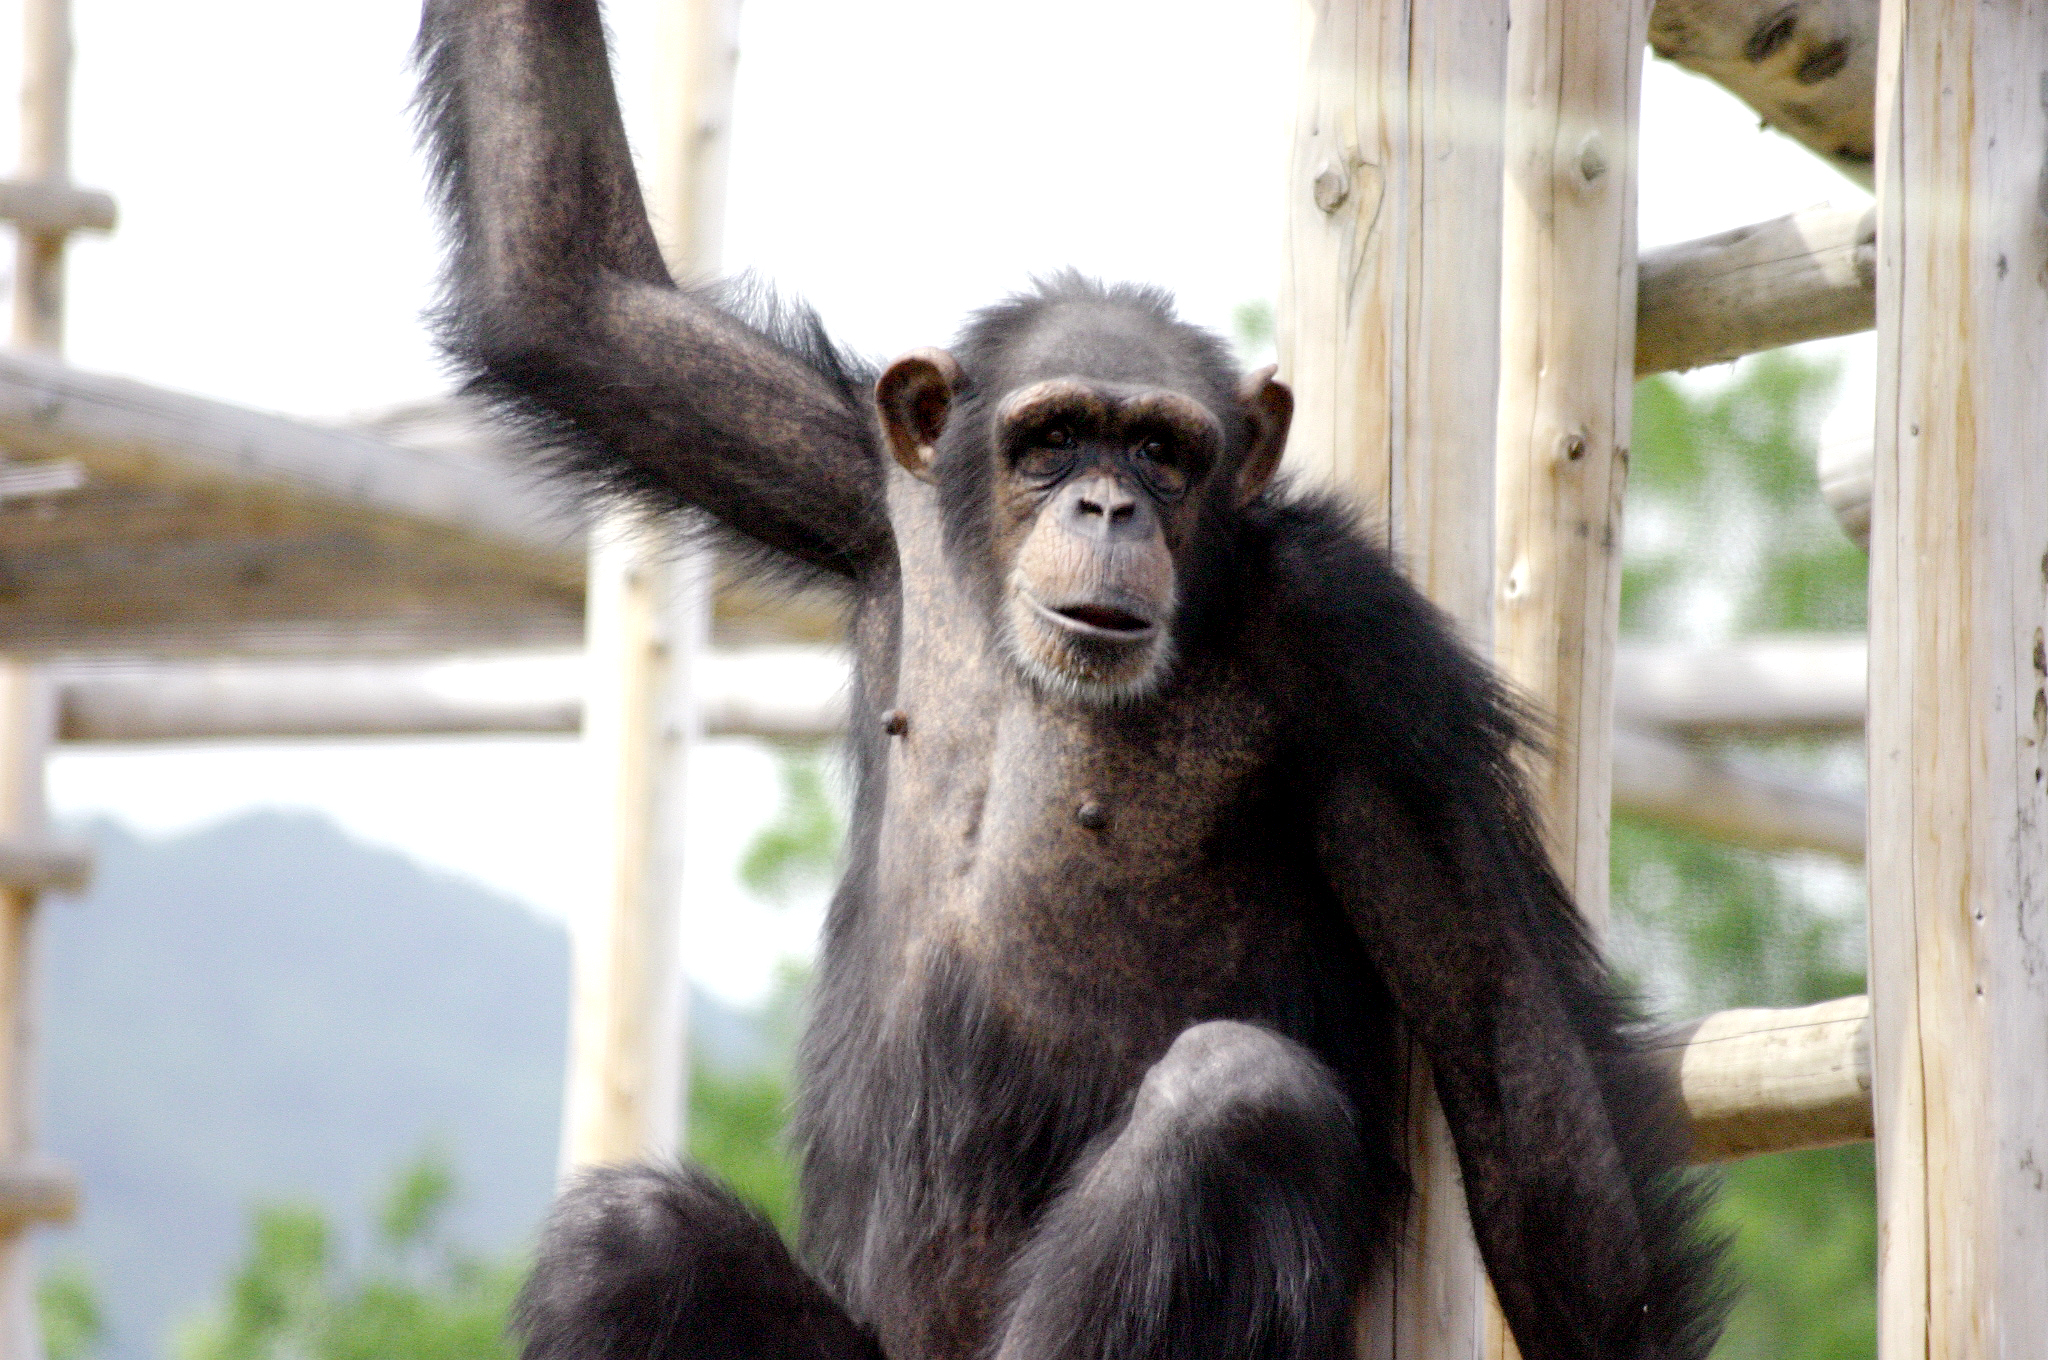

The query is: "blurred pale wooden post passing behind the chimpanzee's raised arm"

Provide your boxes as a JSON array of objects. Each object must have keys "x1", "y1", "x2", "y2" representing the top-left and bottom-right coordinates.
[{"x1": 561, "y1": 0, "x2": 737, "y2": 1170}]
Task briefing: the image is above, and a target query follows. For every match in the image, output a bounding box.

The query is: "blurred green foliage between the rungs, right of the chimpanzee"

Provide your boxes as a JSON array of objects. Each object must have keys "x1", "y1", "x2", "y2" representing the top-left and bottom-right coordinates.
[{"x1": 1612, "y1": 352, "x2": 1876, "y2": 1360}]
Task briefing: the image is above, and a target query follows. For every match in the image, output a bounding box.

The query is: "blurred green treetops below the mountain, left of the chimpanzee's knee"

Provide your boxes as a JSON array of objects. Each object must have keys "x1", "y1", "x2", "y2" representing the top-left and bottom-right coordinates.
[{"x1": 176, "y1": 1151, "x2": 524, "y2": 1360}]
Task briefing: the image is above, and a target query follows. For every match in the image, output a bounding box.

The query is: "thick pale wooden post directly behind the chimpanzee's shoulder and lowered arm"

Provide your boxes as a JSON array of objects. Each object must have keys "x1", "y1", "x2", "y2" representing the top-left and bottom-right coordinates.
[{"x1": 1278, "y1": 0, "x2": 1507, "y2": 1360}]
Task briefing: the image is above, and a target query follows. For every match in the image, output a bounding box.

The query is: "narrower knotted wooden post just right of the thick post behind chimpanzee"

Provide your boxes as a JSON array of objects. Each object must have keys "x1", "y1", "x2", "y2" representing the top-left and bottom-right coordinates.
[{"x1": 1487, "y1": 0, "x2": 1651, "y2": 1358}]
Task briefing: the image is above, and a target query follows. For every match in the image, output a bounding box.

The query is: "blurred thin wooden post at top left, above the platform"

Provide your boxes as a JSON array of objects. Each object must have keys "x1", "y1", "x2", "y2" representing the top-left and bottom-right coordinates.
[{"x1": 14, "y1": 0, "x2": 72, "y2": 354}]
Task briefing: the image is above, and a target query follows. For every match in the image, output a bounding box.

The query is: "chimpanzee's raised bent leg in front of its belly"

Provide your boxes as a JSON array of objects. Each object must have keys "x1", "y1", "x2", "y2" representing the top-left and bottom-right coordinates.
[{"x1": 995, "y1": 1020, "x2": 1374, "y2": 1360}]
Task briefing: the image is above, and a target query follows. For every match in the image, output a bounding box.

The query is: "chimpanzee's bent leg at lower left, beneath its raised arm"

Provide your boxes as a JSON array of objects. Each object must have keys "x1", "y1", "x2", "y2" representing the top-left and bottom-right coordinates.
[{"x1": 512, "y1": 1165, "x2": 881, "y2": 1360}]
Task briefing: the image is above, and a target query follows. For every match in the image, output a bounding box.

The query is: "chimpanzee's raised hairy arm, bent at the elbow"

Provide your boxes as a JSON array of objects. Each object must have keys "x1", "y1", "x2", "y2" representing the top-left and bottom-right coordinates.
[{"x1": 418, "y1": 0, "x2": 887, "y2": 576}]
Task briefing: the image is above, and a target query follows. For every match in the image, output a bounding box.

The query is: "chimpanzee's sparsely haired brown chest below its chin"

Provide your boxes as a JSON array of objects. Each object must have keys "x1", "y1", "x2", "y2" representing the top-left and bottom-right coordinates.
[{"x1": 872, "y1": 626, "x2": 1307, "y2": 1061}]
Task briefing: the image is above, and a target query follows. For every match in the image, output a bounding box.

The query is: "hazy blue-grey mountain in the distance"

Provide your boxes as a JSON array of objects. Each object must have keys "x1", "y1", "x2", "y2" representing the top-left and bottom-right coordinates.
[{"x1": 39, "y1": 813, "x2": 762, "y2": 1360}]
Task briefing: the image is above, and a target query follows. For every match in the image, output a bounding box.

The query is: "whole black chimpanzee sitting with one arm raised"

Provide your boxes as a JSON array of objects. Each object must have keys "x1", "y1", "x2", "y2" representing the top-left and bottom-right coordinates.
[{"x1": 420, "y1": 0, "x2": 1718, "y2": 1360}]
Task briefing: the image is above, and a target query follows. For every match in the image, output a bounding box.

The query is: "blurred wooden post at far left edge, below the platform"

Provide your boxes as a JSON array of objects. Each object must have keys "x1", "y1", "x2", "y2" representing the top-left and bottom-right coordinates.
[{"x1": 0, "y1": 662, "x2": 57, "y2": 1360}]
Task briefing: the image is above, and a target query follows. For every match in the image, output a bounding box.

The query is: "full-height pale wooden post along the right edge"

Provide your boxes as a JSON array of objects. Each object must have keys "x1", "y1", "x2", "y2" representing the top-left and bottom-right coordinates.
[{"x1": 1870, "y1": 0, "x2": 2048, "y2": 1360}]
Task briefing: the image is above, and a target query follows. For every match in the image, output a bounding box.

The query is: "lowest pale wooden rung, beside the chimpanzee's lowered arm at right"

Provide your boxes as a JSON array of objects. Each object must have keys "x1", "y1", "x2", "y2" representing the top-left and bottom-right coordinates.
[{"x1": 1651, "y1": 995, "x2": 1872, "y2": 1161}]
